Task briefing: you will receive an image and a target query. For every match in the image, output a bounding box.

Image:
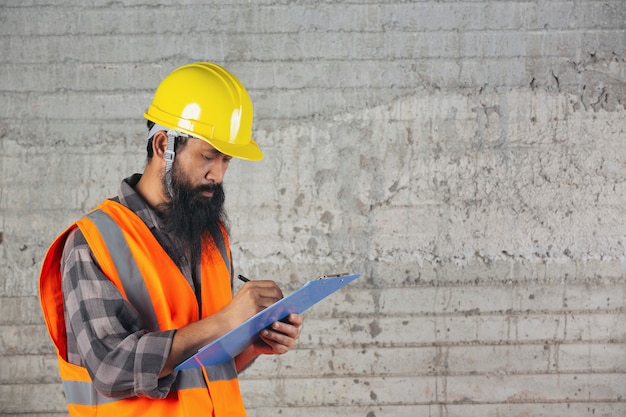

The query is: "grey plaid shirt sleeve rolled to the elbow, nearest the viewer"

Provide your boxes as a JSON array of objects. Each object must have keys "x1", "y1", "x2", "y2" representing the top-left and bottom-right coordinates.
[{"x1": 61, "y1": 228, "x2": 176, "y2": 399}]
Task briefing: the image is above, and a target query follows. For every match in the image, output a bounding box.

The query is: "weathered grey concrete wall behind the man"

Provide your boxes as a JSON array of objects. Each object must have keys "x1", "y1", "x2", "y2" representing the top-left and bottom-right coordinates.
[{"x1": 0, "y1": 0, "x2": 626, "y2": 417}]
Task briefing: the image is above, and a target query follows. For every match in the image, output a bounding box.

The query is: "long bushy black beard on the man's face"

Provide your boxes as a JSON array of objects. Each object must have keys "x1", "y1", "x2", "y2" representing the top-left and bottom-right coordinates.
[{"x1": 158, "y1": 163, "x2": 228, "y2": 267}]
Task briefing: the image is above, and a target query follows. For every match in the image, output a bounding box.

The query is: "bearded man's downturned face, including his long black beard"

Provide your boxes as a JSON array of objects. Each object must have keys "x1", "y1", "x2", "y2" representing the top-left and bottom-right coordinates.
[{"x1": 159, "y1": 139, "x2": 231, "y2": 261}]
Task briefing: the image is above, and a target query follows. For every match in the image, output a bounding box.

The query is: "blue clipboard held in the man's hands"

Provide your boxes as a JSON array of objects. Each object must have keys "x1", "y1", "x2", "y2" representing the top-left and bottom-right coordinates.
[{"x1": 174, "y1": 274, "x2": 361, "y2": 371}]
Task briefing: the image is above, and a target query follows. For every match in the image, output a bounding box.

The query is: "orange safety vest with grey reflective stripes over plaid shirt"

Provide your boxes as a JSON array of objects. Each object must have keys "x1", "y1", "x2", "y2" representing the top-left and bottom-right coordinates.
[{"x1": 39, "y1": 200, "x2": 246, "y2": 417}]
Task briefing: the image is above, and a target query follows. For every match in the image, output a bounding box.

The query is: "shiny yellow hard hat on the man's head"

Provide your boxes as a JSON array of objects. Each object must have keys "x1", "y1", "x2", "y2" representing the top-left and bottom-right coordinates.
[{"x1": 144, "y1": 62, "x2": 263, "y2": 161}]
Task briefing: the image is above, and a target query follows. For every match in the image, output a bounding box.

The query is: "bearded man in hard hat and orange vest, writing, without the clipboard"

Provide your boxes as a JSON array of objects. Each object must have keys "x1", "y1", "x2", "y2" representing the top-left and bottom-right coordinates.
[{"x1": 40, "y1": 62, "x2": 302, "y2": 417}]
